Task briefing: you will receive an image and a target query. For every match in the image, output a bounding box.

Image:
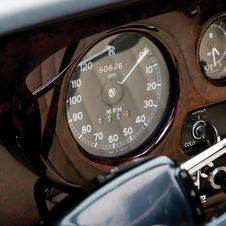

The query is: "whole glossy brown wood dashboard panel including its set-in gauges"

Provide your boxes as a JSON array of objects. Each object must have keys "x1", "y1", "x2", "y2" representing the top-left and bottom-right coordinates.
[{"x1": 0, "y1": 1, "x2": 226, "y2": 226}]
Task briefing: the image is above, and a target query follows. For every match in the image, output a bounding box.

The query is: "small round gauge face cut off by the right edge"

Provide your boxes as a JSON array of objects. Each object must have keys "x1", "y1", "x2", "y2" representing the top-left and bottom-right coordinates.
[{"x1": 199, "y1": 19, "x2": 226, "y2": 79}]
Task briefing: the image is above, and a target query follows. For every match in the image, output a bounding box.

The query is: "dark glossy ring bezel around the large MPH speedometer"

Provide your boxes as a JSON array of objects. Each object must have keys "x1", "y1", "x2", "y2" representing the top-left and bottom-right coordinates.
[{"x1": 62, "y1": 26, "x2": 179, "y2": 165}]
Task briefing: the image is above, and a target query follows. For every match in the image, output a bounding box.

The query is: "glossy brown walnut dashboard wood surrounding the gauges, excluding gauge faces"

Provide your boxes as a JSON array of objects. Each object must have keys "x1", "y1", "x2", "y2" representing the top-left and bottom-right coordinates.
[{"x1": 0, "y1": 0, "x2": 226, "y2": 225}]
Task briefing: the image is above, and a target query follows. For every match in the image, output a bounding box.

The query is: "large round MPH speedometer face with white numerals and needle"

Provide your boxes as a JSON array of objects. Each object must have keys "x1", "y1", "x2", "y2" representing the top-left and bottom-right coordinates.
[{"x1": 66, "y1": 32, "x2": 170, "y2": 158}]
